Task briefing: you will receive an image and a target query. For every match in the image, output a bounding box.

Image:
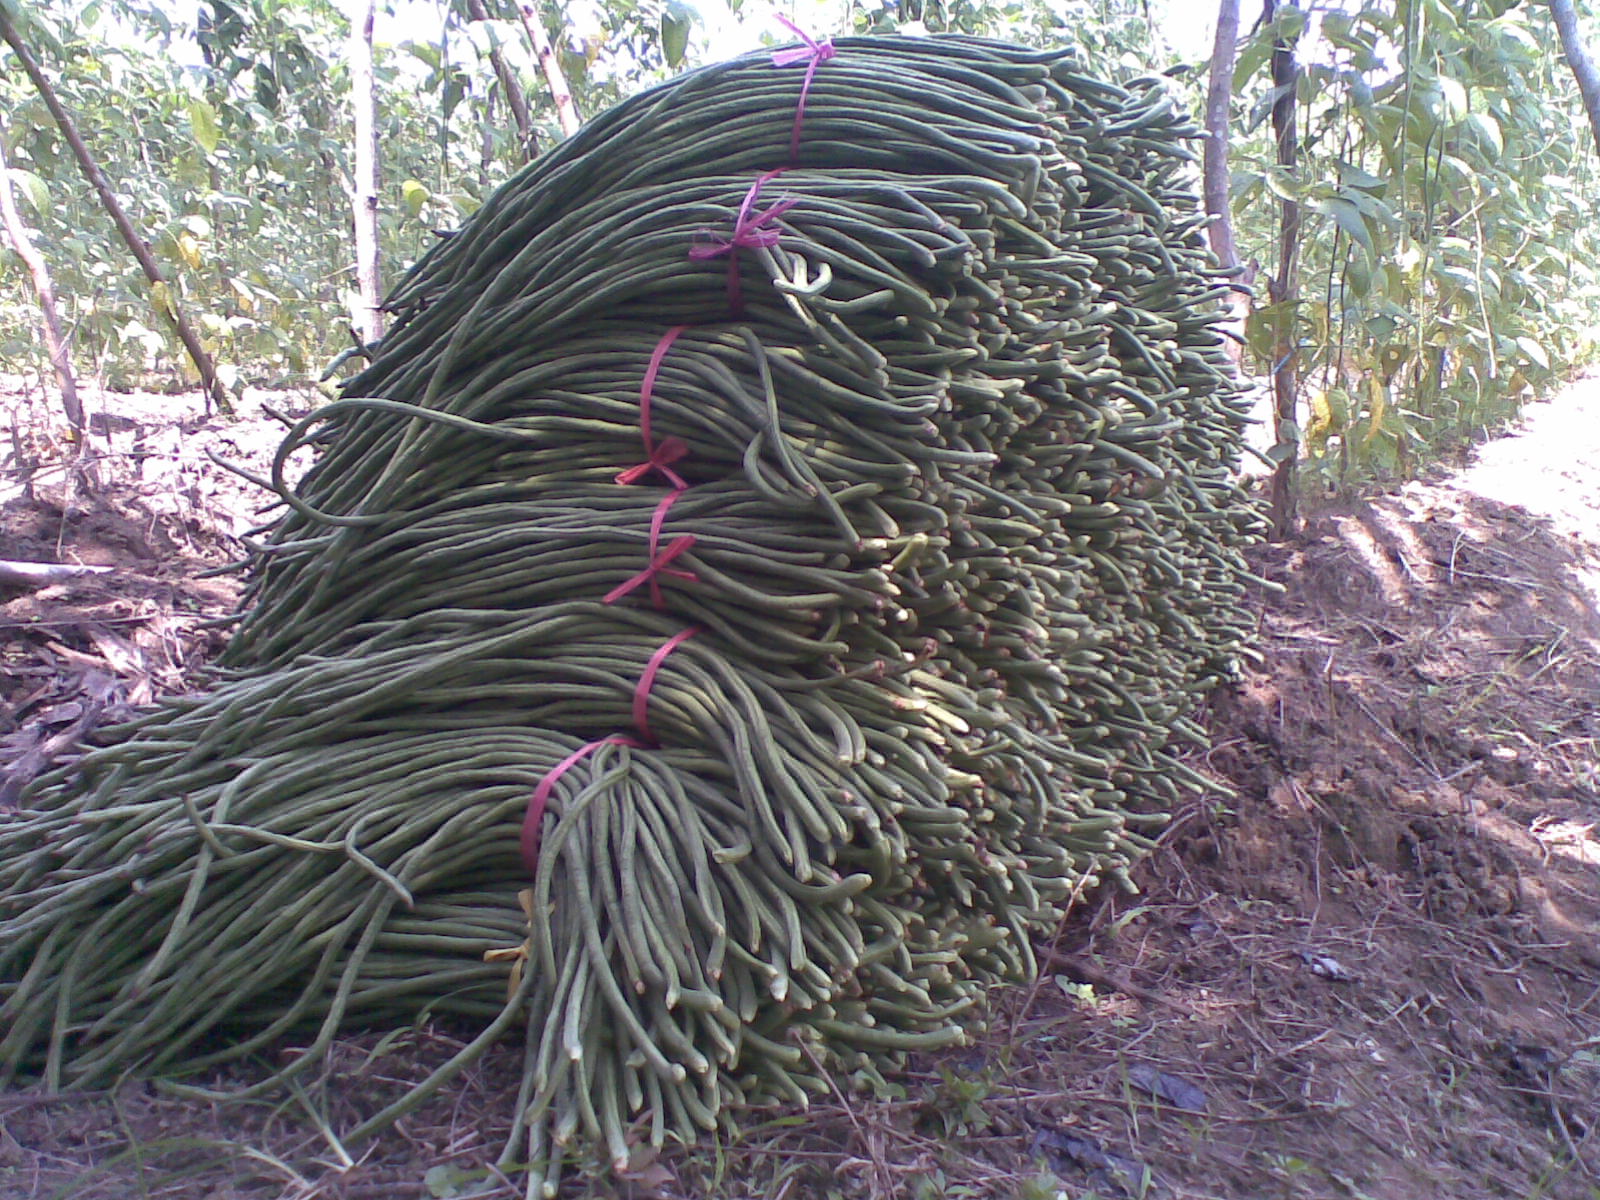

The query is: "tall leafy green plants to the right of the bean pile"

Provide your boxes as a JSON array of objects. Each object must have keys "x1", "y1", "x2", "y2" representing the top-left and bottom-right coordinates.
[{"x1": 1234, "y1": 0, "x2": 1600, "y2": 482}]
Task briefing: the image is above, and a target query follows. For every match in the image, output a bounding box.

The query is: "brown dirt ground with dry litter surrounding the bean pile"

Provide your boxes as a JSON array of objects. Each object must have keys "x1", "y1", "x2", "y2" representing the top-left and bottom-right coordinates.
[{"x1": 0, "y1": 378, "x2": 1600, "y2": 1200}]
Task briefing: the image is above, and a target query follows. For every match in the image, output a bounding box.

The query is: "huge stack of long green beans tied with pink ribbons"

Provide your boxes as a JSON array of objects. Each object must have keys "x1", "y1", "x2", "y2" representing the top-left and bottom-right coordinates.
[{"x1": 0, "y1": 38, "x2": 1258, "y2": 1192}]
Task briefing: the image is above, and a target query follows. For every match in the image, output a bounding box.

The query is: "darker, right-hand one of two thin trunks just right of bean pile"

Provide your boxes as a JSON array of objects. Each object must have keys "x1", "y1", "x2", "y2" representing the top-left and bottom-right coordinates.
[{"x1": 1264, "y1": 0, "x2": 1301, "y2": 538}]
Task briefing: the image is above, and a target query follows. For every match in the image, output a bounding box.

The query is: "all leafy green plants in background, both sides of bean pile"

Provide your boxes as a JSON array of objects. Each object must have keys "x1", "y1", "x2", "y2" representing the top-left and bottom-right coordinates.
[{"x1": 0, "y1": 0, "x2": 1600, "y2": 482}]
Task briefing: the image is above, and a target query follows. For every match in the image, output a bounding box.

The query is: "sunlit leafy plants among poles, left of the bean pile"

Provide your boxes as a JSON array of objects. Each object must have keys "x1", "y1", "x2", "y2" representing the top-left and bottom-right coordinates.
[{"x1": 0, "y1": 0, "x2": 700, "y2": 387}]
